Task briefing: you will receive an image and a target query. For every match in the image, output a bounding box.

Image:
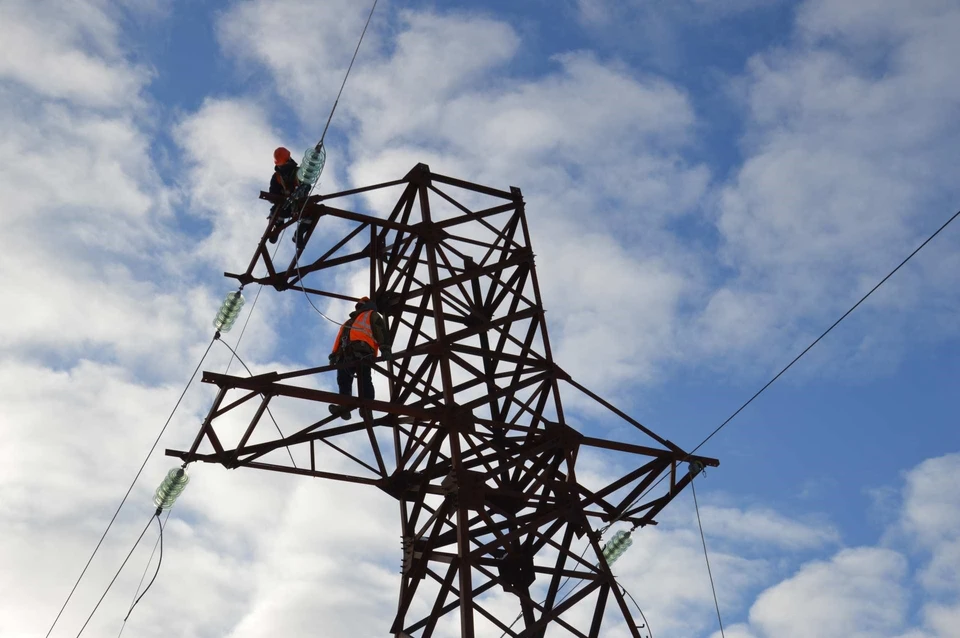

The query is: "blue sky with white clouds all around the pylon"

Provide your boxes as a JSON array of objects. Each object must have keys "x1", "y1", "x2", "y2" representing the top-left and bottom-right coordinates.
[{"x1": 0, "y1": 0, "x2": 960, "y2": 638}]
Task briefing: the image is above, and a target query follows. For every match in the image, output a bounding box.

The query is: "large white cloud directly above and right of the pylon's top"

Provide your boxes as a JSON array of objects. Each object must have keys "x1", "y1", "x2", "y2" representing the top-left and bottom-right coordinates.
[{"x1": 224, "y1": 2, "x2": 709, "y2": 390}]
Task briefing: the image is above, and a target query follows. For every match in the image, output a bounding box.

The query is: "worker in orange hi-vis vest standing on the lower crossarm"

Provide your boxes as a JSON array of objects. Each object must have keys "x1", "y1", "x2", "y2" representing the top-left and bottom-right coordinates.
[{"x1": 330, "y1": 297, "x2": 392, "y2": 419}]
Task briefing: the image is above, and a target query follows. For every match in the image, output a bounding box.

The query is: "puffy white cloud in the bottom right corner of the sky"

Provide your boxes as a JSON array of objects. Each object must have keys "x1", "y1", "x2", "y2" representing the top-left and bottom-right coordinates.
[{"x1": 738, "y1": 454, "x2": 960, "y2": 638}]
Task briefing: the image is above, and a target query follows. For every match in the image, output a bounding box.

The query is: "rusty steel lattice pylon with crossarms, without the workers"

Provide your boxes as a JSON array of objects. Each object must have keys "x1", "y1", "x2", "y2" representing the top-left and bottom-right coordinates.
[{"x1": 167, "y1": 164, "x2": 718, "y2": 638}]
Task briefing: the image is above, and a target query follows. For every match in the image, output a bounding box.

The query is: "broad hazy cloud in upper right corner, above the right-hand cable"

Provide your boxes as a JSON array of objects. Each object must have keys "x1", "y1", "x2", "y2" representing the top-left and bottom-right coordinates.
[{"x1": 705, "y1": 2, "x2": 960, "y2": 370}]
